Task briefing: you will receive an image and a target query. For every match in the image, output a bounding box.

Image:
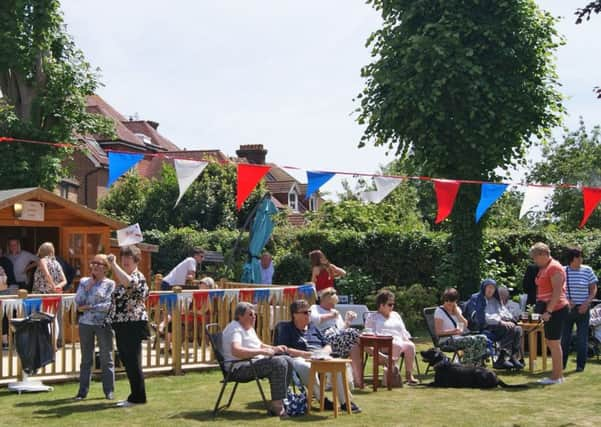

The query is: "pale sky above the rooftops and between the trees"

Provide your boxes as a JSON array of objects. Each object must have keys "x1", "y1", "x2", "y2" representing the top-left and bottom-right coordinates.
[{"x1": 61, "y1": 0, "x2": 601, "y2": 191}]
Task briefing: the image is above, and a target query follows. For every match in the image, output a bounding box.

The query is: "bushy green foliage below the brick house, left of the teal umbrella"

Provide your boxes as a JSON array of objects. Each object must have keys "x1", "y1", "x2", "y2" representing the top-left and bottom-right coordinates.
[{"x1": 99, "y1": 163, "x2": 264, "y2": 231}]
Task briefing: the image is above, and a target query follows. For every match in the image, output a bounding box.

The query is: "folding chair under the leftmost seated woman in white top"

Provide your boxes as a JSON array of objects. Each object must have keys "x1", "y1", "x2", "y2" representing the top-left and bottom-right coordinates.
[{"x1": 205, "y1": 323, "x2": 270, "y2": 417}]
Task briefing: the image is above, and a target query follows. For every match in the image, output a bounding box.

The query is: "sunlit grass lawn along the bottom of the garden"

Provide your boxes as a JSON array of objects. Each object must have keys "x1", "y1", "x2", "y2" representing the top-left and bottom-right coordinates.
[{"x1": 0, "y1": 342, "x2": 601, "y2": 427}]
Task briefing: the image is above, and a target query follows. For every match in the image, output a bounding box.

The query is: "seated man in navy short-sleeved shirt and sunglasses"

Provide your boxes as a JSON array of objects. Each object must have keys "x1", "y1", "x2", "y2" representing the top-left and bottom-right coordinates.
[{"x1": 274, "y1": 299, "x2": 361, "y2": 413}]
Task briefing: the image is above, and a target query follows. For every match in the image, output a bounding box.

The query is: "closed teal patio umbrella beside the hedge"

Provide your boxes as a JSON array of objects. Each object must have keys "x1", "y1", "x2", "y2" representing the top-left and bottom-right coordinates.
[{"x1": 240, "y1": 197, "x2": 277, "y2": 283}]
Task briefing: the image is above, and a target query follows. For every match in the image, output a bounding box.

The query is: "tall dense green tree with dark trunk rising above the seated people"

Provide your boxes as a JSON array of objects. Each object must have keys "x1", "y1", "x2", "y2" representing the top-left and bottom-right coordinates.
[{"x1": 358, "y1": 0, "x2": 562, "y2": 291}]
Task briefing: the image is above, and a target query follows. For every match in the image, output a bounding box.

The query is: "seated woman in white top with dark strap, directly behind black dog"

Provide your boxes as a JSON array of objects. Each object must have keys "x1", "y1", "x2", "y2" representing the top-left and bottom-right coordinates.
[{"x1": 434, "y1": 288, "x2": 488, "y2": 365}]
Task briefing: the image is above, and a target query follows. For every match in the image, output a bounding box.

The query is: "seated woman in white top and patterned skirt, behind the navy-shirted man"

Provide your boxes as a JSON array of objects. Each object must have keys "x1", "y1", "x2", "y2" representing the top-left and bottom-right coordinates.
[{"x1": 311, "y1": 287, "x2": 362, "y2": 385}]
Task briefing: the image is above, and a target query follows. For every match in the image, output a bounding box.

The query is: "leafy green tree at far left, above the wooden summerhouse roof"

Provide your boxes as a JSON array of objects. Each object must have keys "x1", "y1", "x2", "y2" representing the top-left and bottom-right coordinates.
[{"x1": 0, "y1": 0, "x2": 114, "y2": 189}]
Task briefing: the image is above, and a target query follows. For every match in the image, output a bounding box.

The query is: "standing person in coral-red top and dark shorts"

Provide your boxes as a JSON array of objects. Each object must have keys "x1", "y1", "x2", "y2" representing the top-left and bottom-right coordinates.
[{"x1": 530, "y1": 242, "x2": 568, "y2": 385}]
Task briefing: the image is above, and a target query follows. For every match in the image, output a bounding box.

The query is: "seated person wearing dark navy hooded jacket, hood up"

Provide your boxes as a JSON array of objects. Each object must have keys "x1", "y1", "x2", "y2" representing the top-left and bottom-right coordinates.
[{"x1": 468, "y1": 279, "x2": 524, "y2": 369}]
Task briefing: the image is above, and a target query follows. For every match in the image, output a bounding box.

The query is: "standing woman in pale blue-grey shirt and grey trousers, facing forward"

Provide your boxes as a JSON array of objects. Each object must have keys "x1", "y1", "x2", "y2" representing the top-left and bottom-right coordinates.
[{"x1": 75, "y1": 254, "x2": 115, "y2": 400}]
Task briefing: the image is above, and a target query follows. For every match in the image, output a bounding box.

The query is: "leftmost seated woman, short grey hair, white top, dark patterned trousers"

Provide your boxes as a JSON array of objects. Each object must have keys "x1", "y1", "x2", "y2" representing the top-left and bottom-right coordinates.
[{"x1": 222, "y1": 302, "x2": 293, "y2": 417}]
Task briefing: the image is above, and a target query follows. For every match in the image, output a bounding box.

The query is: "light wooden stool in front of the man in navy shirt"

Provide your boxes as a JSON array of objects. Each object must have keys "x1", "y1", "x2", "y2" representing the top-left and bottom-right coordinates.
[{"x1": 307, "y1": 359, "x2": 351, "y2": 417}]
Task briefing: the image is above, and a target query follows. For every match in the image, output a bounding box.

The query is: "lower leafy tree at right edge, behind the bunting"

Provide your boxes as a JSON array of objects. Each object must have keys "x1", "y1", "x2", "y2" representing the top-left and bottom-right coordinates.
[{"x1": 528, "y1": 120, "x2": 601, "y2": 230}]
